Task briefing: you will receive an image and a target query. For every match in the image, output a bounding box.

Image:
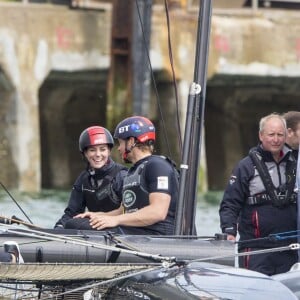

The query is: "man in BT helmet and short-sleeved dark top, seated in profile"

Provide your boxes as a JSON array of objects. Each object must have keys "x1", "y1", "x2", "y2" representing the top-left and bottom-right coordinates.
[{"x1": 77, "y1": 116, "x2": 178, "y2": 235}]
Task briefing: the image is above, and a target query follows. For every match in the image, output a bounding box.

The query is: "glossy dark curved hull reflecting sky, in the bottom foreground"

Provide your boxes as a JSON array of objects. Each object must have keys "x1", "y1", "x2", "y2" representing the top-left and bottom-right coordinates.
[{"x1": 106, "y1": 262, "x2": 299, "y2": 300}]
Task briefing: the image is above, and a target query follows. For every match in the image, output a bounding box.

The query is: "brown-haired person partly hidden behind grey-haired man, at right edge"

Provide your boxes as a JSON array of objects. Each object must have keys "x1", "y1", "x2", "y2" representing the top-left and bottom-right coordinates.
[{"x1": 283, "y1": 111, "x2": 300, "y2": 159}]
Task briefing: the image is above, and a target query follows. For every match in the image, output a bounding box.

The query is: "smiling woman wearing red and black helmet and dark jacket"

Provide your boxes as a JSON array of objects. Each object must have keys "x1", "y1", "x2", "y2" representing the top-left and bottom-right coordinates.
[{"x1": 55, "y1": 126, "x2": 127, "y2": 229}]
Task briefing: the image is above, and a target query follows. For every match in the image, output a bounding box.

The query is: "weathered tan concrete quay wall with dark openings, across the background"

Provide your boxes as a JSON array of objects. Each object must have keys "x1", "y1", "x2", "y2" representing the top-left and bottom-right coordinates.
[{"x1": 0, "y1": 3, "x2": 300, "y2": 191}]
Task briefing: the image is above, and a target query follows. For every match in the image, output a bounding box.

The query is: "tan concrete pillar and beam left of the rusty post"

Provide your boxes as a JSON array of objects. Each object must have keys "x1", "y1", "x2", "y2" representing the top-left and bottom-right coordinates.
[{"x1": 0, "y1": 3, "x2": 111, "y2": 191}]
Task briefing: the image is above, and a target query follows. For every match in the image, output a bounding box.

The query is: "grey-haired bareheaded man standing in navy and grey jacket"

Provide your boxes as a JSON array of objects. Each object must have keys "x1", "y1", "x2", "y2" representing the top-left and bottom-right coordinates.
[{"x1": 219, "y1": 113, "x2": 298, "y2": 275}]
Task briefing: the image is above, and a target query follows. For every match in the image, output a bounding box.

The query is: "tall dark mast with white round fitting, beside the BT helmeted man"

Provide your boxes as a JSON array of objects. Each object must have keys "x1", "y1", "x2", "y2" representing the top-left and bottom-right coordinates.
[{"x1": 175, "y1": 0, "x2": 212, "y2": 235}]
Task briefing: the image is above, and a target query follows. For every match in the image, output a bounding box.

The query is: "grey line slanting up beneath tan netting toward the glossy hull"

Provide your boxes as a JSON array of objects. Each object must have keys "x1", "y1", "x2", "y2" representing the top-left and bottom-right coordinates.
[{"x1": 40, "y1": 265, "x2": 166, "y2": 300}]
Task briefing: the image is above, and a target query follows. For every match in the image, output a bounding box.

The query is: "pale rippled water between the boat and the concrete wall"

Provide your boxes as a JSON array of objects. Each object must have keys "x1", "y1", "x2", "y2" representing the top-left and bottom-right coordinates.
[{"x1": 0, "y1": 190, "x2": 220, "y2": 236}]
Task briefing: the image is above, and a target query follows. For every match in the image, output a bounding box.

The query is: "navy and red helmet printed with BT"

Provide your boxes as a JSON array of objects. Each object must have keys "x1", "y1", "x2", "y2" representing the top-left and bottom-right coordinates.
[{"x1": 114, "y1": 116, "x2": 155, "y2": 143}]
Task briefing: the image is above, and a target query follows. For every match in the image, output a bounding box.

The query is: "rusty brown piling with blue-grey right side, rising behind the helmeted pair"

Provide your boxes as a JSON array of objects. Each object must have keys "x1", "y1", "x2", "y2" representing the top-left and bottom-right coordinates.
[{"x1": 107, "y1": 0, "x2": 152, "y2": 130}]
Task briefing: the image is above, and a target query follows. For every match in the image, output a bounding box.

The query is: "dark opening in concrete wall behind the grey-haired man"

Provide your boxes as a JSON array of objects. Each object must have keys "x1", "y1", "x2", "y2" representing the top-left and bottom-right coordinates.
[{"x1": 205, "y1": 75, "x2": 300, "y2": 190}]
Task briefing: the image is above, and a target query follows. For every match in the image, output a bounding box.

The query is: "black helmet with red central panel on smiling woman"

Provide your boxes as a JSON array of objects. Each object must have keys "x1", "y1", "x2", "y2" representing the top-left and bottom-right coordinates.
[{"x1": 79, "y1": 126, "x2": 114, "y2": 152}]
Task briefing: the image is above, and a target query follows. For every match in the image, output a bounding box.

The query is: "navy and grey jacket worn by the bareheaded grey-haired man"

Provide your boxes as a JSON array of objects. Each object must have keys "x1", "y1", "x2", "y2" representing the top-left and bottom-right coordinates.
[{"x1": 219, "y1": 146, "x2": 297, "y2": 249}]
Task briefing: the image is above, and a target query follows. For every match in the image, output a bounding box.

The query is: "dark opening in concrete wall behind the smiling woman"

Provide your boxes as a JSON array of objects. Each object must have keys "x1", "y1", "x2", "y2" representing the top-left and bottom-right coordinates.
[{"x1": 39, "y1": 71, "x2": 107, "y2": 189}]
